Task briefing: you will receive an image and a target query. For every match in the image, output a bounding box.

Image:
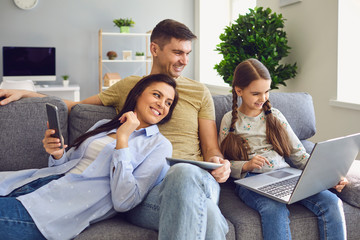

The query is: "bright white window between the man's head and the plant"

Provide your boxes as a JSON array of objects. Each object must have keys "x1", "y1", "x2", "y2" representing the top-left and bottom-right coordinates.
[{"x1": 195, "y1": 0, "x2": 256, "y2": 93}]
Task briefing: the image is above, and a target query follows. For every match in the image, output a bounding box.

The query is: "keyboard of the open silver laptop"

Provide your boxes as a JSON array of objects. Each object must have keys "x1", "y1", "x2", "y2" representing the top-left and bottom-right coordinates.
[{"x1": 259, "y1": 176, "x2": 300, "y2": 198}]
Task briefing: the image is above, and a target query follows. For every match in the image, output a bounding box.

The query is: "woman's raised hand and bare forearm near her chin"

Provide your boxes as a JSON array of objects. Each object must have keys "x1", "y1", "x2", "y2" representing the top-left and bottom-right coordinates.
[{"x1": 116, "y1": 111, "x2": 140, "y2": 149}]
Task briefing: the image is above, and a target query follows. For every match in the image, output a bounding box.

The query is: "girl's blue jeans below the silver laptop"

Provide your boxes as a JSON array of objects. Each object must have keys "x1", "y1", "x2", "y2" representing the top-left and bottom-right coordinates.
[{"x1": 236, "y1": 174, "x2": 346, "y2": 240}]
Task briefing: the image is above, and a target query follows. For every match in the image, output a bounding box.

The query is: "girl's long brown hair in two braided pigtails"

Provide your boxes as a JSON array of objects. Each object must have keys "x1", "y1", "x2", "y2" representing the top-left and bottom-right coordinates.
[{"x1": 220, "y1": 58, "x2": 291, "y2": 161}]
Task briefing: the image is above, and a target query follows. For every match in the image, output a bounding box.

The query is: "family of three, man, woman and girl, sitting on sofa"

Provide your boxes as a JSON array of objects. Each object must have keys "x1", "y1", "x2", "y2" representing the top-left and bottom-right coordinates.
[{"x1": 0, "y1": 19, "x2": 347, "y2": 240}]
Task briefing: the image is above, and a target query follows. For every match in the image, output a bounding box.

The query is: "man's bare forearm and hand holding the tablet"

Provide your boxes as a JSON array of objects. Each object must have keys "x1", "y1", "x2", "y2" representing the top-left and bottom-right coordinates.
[{"x1": 199, "y1": 118, "x2": 231, "y2": 183}]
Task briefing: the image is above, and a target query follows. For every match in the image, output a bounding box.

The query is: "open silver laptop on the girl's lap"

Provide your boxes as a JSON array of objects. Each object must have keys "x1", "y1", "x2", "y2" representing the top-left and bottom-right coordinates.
[{"x1": 235, "y1": 133, "x2": 360, "y2": 204}]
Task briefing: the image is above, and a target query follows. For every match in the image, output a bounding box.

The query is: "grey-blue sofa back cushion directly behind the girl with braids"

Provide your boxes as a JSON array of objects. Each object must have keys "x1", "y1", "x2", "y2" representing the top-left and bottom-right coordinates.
[{"x1": 213, "y1": 92, "x2": 316, "y2": 140}]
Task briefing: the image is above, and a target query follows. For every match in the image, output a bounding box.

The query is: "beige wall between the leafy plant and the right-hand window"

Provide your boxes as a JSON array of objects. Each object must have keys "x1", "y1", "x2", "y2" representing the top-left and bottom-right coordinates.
[{"x1": 257, "y1": 0, "x2": 360, "y2": 142}]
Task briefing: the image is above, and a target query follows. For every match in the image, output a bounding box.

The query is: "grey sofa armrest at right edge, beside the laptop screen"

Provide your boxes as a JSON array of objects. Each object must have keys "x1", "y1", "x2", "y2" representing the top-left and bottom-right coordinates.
[{"x1": 337, "y1": 160, "x2": 360, "y2": 208}]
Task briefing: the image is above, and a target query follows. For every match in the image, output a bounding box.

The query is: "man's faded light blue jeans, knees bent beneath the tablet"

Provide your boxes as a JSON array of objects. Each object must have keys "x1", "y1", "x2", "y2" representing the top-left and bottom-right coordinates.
[{"x1": 127, "y1": 163, "x2": 228, "y2": 240}]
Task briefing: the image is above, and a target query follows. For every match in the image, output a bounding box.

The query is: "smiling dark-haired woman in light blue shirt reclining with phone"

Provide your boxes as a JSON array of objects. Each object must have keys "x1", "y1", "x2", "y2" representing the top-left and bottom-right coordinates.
[{"x1": 0, "y1": 74, "x2": 178, "y2": 239}]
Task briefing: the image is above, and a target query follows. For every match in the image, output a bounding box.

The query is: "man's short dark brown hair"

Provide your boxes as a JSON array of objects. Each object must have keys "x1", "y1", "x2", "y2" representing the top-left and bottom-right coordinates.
[{"x1": 150, "y1": 19, "x2": 197, "y2": 48}]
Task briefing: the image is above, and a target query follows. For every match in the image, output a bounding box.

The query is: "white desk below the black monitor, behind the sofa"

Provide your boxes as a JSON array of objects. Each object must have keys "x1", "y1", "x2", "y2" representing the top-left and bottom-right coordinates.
[{"x1": 35, "y1": 85, "x2": 80, "y2": 102}]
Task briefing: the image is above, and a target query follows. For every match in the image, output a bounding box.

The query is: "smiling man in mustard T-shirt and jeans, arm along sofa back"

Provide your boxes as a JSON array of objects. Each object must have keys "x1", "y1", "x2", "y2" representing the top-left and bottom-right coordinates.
[{"x1": 0, "y1": 19, "x2": 230, "y2": 240}]
